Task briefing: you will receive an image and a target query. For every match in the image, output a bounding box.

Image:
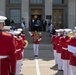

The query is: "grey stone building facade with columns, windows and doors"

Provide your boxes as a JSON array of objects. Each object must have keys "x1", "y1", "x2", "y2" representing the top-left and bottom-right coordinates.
[{"x1": 0, "y1": 0, "x2": 76, "y2": 28}]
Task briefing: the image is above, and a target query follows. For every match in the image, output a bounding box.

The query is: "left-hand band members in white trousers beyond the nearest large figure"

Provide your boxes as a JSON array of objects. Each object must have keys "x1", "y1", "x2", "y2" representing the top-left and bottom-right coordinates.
[{"x1": 3, "y1": 26, "x2": 28, "y2": 75}]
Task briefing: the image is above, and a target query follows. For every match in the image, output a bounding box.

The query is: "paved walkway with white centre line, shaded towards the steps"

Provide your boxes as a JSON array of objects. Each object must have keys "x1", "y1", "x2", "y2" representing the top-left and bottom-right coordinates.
[{"x1": 21, "y1": 44, "x2": 63, "y2": 75}]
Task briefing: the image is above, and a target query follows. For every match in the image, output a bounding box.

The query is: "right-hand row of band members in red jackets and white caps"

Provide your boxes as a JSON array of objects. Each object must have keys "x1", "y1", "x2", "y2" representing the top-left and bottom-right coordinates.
[{"x1": 52, "y1": 29, "x2": 76, "y2": 75}]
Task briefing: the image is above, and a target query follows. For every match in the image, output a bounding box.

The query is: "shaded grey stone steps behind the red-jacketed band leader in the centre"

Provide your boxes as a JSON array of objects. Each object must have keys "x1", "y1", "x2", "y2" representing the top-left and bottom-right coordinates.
[{"x1": 25, "y1": 30, "x2": 52, "y2": 50}]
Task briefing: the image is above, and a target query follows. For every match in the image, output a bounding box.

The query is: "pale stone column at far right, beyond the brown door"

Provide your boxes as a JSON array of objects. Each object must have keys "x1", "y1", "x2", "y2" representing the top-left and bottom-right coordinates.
[{"x1": 68, "y1": 0, "x2": 76, "y2": 29}]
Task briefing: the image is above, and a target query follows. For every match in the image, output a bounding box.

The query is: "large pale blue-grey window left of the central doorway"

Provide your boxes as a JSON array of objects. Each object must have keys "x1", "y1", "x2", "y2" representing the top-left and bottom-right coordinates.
[{"x1": 10, "y1": 9, "x2": 20, "y2": 23}]
